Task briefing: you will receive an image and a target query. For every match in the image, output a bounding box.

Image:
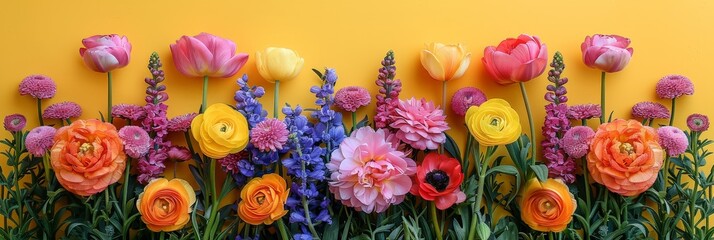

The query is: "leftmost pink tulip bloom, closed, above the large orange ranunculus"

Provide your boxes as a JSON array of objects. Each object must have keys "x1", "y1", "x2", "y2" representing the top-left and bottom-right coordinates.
[{"x1": 79, "y1": 34, "x2": 131, "y2": 73}]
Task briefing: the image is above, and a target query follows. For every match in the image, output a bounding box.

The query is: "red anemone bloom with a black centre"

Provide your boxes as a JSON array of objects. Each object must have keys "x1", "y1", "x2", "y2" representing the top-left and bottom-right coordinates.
[{"x1": 410, "y1": 152, "x2": 466, "y2": 210}]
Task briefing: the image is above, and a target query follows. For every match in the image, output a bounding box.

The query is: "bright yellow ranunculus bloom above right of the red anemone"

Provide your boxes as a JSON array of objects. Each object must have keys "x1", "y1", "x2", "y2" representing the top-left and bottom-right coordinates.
[{"x1": 465, "y1": 98, "x2": 521, "y2": 146}]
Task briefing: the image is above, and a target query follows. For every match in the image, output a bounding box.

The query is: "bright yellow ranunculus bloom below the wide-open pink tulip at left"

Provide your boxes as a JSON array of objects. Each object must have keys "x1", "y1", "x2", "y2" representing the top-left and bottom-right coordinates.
[{"x1": 191, "y1": 103, "x2": 249, "y2": 159}]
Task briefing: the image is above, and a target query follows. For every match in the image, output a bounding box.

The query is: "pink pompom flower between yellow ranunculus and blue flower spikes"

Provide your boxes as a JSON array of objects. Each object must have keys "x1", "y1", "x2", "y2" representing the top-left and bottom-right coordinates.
[{"x1": 250, "y1": 118, "x2": 289, "y2": 152}]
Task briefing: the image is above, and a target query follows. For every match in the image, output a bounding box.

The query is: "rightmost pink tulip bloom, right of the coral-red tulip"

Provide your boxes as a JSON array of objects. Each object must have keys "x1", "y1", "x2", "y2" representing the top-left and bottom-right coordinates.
[{"x1": 580, "y1": 34, "x2": 632, "y2": 72}]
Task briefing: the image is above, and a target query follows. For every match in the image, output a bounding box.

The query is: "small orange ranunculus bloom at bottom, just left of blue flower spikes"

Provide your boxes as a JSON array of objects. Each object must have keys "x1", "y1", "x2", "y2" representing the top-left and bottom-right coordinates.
[{"x1": 238, "y1": 173, "x2": 290, "y2": 225}]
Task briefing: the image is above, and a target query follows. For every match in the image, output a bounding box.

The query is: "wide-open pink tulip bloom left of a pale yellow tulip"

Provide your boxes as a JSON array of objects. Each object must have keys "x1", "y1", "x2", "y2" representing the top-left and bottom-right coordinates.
[{"x1": 171, "y1": 33, "x2": 248, "y2": 78}]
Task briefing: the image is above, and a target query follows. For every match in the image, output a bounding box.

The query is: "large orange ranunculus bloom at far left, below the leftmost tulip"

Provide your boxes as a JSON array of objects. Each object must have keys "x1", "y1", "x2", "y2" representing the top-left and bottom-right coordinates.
[{"x1": 50, "y1": 119, "x2": 126, "y2": 196}]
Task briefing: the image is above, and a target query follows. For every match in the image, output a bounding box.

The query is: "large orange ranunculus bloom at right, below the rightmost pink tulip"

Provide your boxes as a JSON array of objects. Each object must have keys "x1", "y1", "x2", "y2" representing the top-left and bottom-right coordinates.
[{"x1": 587, "y1": 119, "x2": 664, "y2": 197}]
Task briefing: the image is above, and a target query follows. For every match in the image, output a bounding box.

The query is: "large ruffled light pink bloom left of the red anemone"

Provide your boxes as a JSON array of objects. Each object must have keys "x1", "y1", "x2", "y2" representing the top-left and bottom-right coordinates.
[{"x1": 326, "y1": 127, "x2": 416, "y2": 213}]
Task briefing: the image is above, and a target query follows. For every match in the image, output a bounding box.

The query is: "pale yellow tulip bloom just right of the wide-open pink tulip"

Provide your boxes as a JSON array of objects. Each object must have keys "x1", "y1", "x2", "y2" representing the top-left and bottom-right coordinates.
[{"x1": 255, "y1": 47, "x2": 305, "y2": 83}]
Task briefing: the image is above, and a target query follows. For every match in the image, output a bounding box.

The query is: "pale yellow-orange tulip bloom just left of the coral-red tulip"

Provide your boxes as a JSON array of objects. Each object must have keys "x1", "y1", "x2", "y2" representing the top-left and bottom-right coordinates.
[{"x1": 421, "y1": 43, "x2": 471, "y2": 82}]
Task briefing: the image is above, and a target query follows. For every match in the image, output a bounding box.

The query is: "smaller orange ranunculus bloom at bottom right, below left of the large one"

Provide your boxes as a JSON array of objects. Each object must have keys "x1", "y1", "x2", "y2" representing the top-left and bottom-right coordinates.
[{"x1": 520, "y1": 178, "x2": 577, "y2": 232}]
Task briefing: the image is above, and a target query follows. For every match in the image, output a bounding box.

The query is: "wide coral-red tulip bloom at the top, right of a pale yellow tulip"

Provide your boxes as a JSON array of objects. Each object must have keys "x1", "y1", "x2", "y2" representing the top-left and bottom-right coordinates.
[{"x1": 481, "y1": 34, "x2": 548, "y2": 85}]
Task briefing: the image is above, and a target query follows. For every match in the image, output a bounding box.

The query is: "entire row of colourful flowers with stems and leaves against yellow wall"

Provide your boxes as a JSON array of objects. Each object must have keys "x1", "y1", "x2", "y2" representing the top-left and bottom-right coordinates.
[{"x1": 0, "y1": 33, "x2": 714, "y2": 239}]
